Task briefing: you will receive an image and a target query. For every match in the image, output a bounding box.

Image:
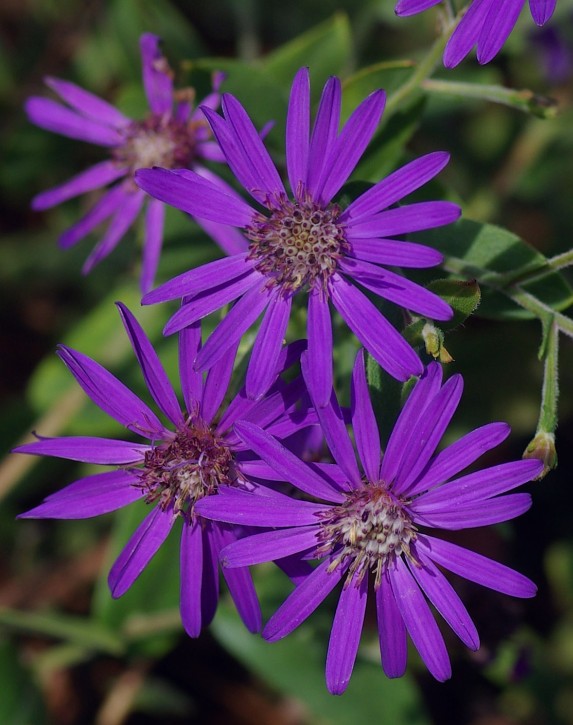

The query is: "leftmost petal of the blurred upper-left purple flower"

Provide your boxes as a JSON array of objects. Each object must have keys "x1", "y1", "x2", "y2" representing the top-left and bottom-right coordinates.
[{"x1": 25, "y1": 96, "x2": 123, "y2": 146}]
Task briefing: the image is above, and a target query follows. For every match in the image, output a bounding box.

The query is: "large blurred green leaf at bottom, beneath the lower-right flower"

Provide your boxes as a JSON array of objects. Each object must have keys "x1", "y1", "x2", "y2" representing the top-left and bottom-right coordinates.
[{"x1": 212, "y1": 604, "x2": 429, "y2": 725}]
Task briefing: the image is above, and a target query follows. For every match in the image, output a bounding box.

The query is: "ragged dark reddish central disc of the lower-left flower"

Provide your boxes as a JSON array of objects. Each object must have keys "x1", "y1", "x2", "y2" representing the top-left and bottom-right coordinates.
[{"x1": 137, "y1": 418, "x2": 236, "y2": 521}]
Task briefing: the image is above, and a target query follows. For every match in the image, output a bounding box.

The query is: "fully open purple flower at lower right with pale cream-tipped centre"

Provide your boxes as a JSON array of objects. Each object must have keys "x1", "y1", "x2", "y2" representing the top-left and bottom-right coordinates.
[{"x1": 198, "y1": 353, "x2": 542, "y2": 694}]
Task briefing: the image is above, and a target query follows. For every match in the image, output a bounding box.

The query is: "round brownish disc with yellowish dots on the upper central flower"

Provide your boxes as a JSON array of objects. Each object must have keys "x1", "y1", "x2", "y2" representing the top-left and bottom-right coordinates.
[{"x1": 246, "y1": 197, "x2": 349, "y2": 292}]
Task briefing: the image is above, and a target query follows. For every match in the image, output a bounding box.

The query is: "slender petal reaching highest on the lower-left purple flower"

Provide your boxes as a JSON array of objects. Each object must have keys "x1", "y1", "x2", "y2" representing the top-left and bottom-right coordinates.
[{"x1": 116, "y1": 302, "x2": 184, "y2": 427}]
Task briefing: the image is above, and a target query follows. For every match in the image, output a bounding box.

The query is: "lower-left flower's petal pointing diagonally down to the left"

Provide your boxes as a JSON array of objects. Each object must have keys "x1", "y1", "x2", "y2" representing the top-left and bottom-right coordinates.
[{"x1": 108, "y1": 506, "x2": 175, "y2": 599}]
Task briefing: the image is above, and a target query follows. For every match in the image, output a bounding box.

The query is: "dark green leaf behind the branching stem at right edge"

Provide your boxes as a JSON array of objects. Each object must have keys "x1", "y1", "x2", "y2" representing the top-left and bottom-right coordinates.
[{"x1": 416, "y1": 219, "x2": 573, "y2": 320}]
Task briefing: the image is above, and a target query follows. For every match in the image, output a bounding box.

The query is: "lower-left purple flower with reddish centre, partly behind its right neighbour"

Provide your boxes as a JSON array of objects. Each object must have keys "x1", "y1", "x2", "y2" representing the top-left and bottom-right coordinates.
[{"x1": 16, "y1": 304, "x2": 316, "y2": 637}]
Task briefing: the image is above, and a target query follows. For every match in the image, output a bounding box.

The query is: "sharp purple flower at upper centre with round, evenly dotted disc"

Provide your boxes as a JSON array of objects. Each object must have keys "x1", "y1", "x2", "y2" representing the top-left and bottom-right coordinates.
[{"x1": 136, "y1": 68, "x2": 460, "y2": 405}]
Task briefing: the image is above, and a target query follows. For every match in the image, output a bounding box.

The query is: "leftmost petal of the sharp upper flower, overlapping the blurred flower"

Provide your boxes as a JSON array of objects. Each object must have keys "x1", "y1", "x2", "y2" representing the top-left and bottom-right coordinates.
[{"x1": 135, "y1": 168, "x2": 254, "y2": 227}]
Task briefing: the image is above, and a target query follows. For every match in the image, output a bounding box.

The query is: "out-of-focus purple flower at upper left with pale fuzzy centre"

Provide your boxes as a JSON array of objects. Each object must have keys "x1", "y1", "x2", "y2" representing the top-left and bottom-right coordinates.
[{"x1": 26, "y1": 33, "x2": 241, "y2": 292}]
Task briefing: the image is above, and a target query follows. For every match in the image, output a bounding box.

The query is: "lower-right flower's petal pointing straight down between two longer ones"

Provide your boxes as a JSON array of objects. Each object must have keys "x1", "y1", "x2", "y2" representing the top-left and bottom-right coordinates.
[{"x1": 376, "y1": 571, "x2": 408, "y2": 678}]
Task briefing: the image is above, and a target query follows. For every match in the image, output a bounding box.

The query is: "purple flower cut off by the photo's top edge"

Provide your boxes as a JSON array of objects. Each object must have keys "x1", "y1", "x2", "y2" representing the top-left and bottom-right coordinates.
[{"x1": 396, "y1": 0, "x2": 557, "y2": 68}]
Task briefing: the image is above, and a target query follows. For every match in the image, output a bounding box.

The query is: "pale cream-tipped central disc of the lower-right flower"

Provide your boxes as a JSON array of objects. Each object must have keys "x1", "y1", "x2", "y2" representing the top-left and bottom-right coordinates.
[{"x1": 319, "y1": 483, "x2": 416, "y2": 588}]
